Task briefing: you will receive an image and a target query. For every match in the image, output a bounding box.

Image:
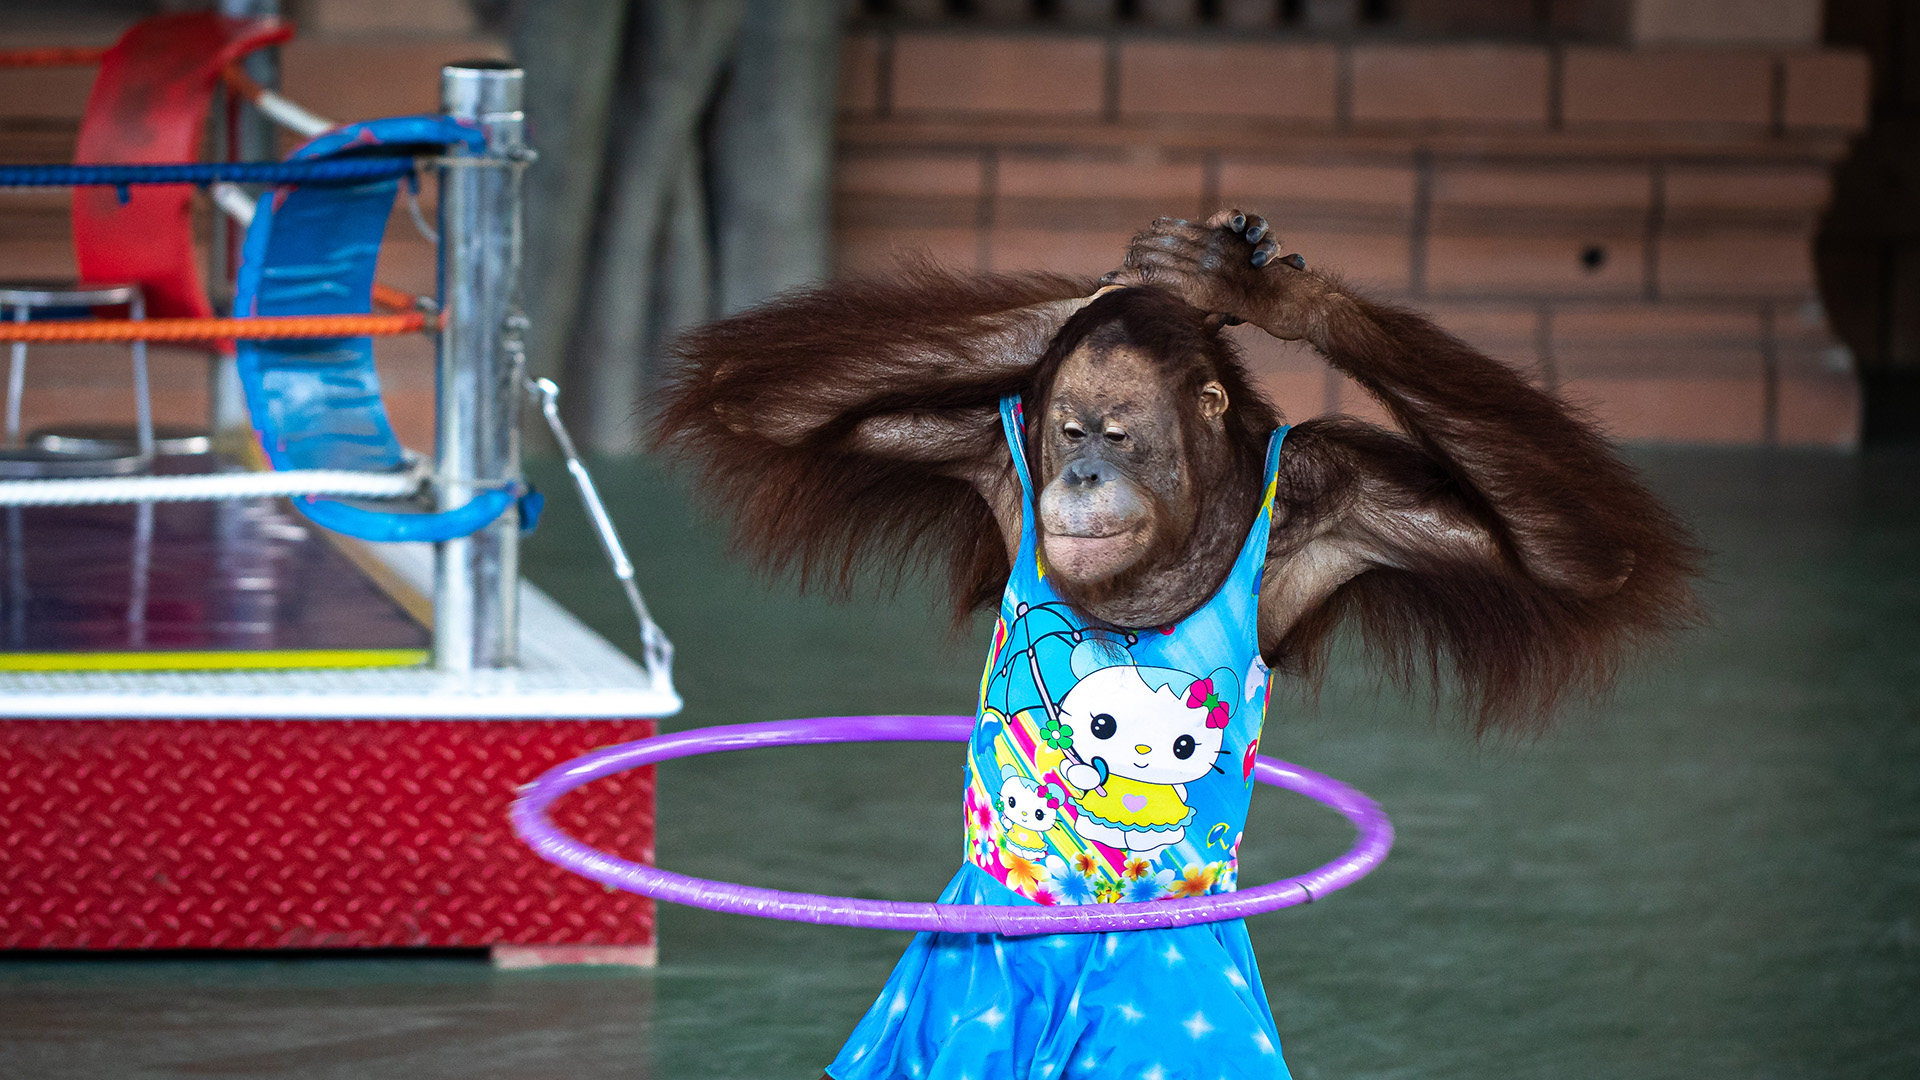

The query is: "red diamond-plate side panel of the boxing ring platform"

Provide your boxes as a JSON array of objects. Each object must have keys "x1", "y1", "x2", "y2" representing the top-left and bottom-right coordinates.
[{"x1": 0, "y1": 719, "x2": 655, "y2": 963}]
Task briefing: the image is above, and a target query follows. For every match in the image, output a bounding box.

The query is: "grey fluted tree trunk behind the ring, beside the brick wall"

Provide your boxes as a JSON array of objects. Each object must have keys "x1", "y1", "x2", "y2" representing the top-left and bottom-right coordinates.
[{"x1": 513, "y1": 0, "x2": 839, "y2": 452}]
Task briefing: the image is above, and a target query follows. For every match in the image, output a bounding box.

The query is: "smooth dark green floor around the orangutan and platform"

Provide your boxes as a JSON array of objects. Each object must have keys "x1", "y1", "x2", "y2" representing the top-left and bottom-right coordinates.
[{"x1": 0, "y1": 452, "x2": 1920, "y2": 1080}]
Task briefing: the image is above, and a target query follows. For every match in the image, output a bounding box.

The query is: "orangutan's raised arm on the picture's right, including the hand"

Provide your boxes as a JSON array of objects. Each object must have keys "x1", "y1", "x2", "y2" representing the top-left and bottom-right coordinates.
[{"x1": 1106, "y1": 211, "x2": 1699, "y2": 724}]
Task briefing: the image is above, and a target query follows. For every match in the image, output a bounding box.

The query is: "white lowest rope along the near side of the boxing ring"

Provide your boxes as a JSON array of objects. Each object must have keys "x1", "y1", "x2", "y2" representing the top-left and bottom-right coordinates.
[{"x1": 0, "y1": 469, "x2": 424, "y2": 505}]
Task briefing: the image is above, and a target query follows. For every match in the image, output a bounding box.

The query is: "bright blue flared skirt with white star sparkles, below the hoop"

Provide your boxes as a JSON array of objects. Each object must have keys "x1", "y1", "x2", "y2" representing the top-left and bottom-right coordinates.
[{"x1": 828, "y1": 865, "x2": 1286, "y2": 1080}]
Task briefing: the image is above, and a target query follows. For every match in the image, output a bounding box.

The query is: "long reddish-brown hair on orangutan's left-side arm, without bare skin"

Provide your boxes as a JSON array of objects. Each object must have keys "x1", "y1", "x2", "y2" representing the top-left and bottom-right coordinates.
[{"x1": 655, "y1": 263, "x2": 1094, "y2": 625}]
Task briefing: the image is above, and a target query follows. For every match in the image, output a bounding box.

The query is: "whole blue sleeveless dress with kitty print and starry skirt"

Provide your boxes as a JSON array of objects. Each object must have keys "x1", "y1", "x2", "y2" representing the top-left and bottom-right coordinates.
[{"x1": 828, "y1": 398, "x2": 1288, "y2": 1080}]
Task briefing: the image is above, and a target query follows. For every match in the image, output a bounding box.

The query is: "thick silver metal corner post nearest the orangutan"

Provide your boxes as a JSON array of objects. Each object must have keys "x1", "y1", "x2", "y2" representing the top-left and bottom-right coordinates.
[{"x1": 434, "y1": 60, "x2": 530, "y2": 671}]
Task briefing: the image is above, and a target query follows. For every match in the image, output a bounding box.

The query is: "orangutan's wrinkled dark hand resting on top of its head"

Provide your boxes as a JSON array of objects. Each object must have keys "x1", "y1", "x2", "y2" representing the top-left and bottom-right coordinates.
[{"x1": 1100, "y1": 209, "x2": 1332, "y2": 340}]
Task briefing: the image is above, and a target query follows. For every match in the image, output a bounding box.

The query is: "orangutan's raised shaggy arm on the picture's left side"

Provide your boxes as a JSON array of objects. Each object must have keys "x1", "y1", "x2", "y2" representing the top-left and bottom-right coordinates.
[{"x1": 655, "y1": 265, "x2": 1094, "y2": 623}]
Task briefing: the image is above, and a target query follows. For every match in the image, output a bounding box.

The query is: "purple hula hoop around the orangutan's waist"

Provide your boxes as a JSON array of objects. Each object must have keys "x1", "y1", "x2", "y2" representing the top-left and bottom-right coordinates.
[{"x1": 511, "y1": 717, "x2": 1394, "y2": 936}]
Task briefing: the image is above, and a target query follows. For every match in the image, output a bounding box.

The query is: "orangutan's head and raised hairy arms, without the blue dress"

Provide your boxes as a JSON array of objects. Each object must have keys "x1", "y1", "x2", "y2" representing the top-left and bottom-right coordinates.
[{"x1": 659, "y1": 211, "x2": 1699, "y2": 730}]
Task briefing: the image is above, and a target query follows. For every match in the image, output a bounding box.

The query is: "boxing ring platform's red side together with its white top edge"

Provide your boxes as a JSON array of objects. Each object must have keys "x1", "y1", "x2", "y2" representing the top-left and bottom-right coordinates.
[{"x1": 0, "y1": 544, "x2": 680, "y2": 949}]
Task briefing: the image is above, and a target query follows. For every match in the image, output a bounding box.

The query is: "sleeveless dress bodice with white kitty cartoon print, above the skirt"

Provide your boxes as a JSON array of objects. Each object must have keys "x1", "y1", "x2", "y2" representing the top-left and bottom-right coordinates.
[{"x1": 966, "y1": 398, "x2": 1284, "y2": 903}]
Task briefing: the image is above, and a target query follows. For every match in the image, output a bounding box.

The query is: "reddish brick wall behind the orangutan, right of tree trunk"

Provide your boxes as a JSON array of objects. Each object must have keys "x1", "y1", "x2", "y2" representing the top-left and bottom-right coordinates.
[{"x1": 837, "y1": 31, "x2": 1868, "y2": 446}]
